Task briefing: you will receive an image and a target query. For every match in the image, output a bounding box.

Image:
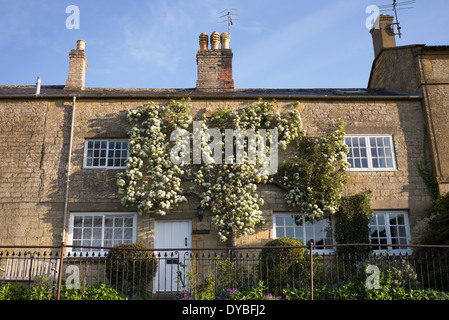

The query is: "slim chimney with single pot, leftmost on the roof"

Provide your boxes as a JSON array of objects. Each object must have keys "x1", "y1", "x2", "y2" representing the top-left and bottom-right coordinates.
[{"x1": 64, "y1": 40, "x2": 87, "y2": 91}]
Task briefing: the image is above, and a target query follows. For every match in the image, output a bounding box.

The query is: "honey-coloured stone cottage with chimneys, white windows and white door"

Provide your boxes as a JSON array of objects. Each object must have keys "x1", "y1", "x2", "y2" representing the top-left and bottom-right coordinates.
[{"x1": 0, "y1": 15, "x2": 449, "y2": 260}]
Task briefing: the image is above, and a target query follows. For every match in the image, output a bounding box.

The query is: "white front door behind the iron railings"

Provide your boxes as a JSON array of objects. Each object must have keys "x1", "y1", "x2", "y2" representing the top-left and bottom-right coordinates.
[{"x1": 153, "y1": 220, "x2": 192, "y2": 292}]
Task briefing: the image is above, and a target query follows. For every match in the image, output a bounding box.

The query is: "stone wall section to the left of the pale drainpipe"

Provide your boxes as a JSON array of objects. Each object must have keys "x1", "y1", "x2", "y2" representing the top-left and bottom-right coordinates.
[{"x1": 0, "y1": 100, "x2": 71, "y2": 245}]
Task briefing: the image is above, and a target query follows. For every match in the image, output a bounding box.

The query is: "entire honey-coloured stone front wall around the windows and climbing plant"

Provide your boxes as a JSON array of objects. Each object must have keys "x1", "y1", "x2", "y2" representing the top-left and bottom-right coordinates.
[{"x1": 0, "y1": 97, "x2": 431, "y2": 247}]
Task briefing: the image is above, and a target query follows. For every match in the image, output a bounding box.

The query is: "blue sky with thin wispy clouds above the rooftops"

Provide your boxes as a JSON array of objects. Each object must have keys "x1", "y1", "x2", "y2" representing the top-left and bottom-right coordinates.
[{"x1": 0, "y1": 0, "x2": 449, "y2": 89}]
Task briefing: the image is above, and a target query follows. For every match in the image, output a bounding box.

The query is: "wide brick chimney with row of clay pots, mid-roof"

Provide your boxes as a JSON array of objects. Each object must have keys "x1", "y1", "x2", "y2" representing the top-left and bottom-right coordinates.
[{"x1": 196, "y1": 31, "x2": 234, "y2": 91}]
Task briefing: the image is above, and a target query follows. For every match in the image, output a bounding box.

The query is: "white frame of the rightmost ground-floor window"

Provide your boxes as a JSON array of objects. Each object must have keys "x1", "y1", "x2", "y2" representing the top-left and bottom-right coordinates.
[{"x1": 369, "y1": 210, "x2": 411, "y2": 254}]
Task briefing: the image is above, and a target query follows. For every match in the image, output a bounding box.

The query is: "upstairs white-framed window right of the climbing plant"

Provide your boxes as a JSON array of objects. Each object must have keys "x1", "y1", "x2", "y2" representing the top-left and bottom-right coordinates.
[{"x1": 345, "y1": 135, "x2": 396, "y2": 171}]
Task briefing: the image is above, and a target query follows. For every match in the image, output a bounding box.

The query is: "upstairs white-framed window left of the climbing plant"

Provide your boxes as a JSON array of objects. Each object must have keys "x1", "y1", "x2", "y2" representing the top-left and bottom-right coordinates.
[{"x1": 84, "y1": 140, "x2": 128, "y2": 169}]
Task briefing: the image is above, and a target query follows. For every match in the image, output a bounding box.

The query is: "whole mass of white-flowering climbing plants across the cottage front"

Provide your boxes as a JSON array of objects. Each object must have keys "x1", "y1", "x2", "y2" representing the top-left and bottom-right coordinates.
[{"x1": 117, "y1": 100, "x2": 348, "y2": 241}]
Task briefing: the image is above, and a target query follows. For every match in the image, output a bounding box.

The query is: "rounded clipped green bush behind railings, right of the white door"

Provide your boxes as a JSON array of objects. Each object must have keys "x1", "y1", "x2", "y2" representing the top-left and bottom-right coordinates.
[{"x1": 260, "y1": 238, "x2": 308, "y2": 293}]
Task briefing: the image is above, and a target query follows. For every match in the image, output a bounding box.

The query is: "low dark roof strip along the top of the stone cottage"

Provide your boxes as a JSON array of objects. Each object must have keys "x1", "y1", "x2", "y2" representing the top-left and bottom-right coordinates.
[{"x1": 0, "y1": 86, "x2": 421, "y2": 99}]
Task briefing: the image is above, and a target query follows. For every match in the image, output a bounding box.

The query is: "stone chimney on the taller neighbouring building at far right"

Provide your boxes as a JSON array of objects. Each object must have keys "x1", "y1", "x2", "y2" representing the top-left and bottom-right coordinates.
[{"x1": 370, "y1": 14, "x2": 396, "y2": 57}]
